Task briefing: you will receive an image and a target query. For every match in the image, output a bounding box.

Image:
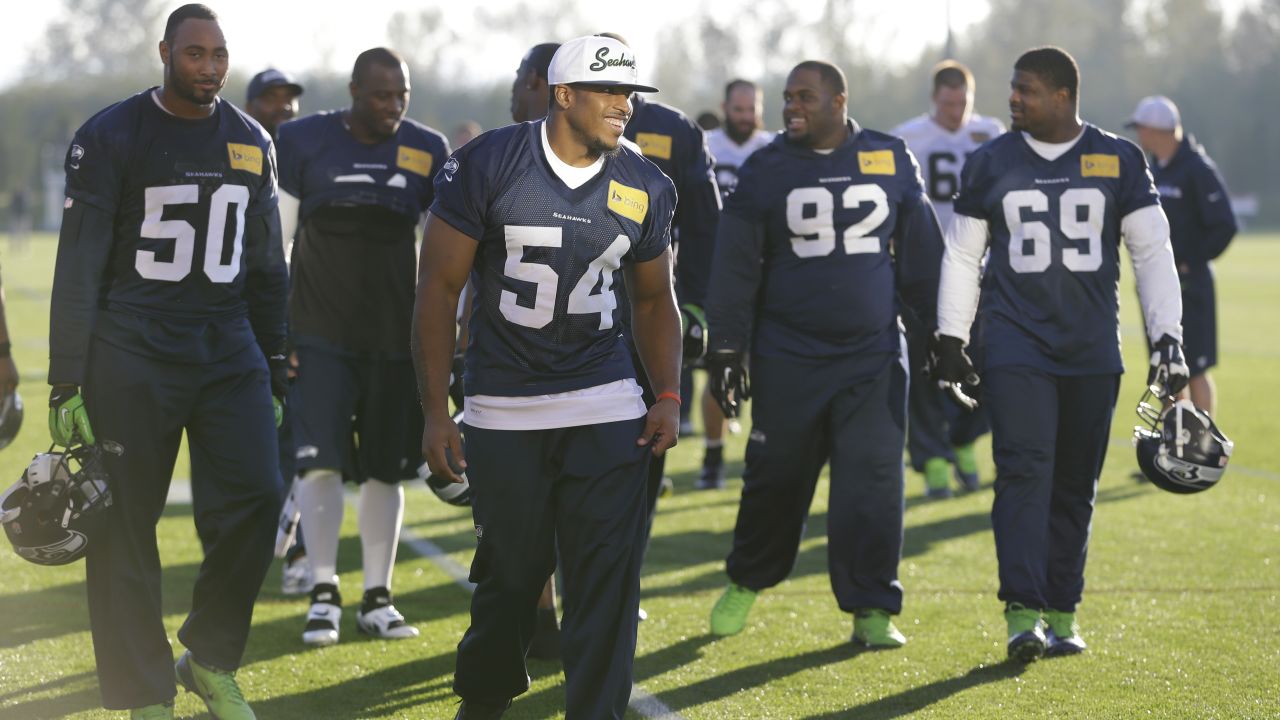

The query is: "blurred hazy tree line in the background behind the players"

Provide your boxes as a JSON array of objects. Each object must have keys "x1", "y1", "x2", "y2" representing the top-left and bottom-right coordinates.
[{"x1": 0, "y1": 0, "x2": 1280, "y2": 225}]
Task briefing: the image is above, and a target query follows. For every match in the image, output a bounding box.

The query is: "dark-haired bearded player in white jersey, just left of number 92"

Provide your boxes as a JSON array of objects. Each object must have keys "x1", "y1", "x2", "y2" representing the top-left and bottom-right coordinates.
[{"x1": 695, "y1": 79, "x2": 773, "y2": 489}]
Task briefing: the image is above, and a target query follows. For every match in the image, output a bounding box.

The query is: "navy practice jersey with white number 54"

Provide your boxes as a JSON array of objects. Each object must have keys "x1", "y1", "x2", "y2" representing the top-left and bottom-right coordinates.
[{"x1": 431, "y1": 120, "x2": 676, "y2": 396}]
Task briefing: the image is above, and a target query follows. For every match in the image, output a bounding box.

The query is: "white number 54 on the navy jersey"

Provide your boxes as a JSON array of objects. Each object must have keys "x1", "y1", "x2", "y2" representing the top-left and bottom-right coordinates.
[{"x1": 498, "y1": 225, "x2": 631, "y2": 331}]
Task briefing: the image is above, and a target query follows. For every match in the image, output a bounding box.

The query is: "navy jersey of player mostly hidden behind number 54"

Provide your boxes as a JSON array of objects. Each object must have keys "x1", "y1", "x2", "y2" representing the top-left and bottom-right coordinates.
[{"x1": 623, "y1": 95, "x2": 721, "y2": 305}]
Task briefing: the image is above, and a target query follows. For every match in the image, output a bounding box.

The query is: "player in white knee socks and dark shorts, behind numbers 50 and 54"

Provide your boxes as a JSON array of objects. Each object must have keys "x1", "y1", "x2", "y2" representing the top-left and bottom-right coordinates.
[{"x1": 279, "y1": 47, "x2": 448, "y2": 646}]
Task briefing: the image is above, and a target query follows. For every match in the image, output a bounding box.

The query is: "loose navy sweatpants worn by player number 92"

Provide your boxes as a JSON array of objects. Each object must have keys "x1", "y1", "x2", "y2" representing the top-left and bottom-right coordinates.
[{"x1": 726, "y1": 355, "x2": 908, "y2": 614}]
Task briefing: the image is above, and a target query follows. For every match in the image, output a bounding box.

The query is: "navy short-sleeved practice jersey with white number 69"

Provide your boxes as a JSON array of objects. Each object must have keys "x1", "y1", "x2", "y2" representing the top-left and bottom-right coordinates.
[{"x1": 955, "y1": 123, "x2": 1158, "y2": 375}]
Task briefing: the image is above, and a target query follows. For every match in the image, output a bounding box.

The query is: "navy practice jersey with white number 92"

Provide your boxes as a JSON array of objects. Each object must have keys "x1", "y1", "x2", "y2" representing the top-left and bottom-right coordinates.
[{"x1": 727, "y1": 120, "x2": 942, "y2": 363}]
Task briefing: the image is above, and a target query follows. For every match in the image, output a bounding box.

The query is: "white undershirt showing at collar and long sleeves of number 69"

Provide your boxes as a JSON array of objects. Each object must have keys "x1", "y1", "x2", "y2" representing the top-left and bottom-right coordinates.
[{"x1": 938, "y1": 129, "x2": 1183, "y2": 343}]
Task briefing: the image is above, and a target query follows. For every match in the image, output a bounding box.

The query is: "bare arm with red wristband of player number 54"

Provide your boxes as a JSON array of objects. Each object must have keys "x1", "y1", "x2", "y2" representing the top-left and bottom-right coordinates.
[{"x1": 626, "y1": 247, "x2": 682, "y2": 455}]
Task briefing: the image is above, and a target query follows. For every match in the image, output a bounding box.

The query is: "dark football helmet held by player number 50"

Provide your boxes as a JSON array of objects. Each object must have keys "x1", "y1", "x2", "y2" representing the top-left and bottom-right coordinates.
[{"x1": 0, "y1": 445, "x2": 111, "y2": 565}]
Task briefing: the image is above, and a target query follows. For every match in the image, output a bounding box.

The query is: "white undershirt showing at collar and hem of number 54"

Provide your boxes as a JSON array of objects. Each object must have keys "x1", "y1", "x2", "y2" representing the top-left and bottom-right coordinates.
[{"x1": 462, "y1": 120, "x2": 649, "y2": 430}]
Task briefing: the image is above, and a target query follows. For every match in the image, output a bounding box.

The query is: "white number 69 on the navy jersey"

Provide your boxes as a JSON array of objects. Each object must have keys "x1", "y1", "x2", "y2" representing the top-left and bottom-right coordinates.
[{"x1": 1002, "y1": 187, "x2": 1107, "y2": 273}]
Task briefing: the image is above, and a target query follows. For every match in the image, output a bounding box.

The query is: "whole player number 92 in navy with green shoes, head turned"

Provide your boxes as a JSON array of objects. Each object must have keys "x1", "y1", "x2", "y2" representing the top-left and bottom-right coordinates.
[{"x1": 707, "y1": 60, "x2": 942, "y2": 647}]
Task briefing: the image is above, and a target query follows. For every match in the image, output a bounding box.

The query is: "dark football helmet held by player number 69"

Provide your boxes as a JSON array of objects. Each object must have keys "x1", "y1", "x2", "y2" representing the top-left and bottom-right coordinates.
[{"x1": 1133, "y1": 387, "x2": 1235, "y2": 495}]
